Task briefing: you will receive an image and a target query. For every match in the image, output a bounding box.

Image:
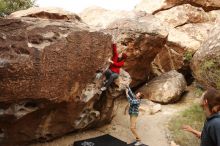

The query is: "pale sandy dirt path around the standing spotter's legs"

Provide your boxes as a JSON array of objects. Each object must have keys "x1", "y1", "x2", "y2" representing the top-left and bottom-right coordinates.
[{"x1": 32, "y1": 86, "x2": 198, "y2": 146}]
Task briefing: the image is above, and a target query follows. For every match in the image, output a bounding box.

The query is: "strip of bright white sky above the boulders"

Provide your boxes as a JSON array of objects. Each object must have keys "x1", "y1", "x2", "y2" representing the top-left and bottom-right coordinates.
[{"x1": 36, "y1": 0, "x2": 140, "y2": 13}]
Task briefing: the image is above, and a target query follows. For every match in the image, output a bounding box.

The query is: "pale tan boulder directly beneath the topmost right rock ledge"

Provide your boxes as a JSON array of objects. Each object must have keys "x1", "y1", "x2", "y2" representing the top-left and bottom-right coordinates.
[{"x1": 155, "y1": 4, "x2": 211, "y2": 27}]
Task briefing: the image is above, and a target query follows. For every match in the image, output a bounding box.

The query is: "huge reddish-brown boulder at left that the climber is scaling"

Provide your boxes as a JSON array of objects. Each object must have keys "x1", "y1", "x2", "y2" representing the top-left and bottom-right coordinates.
[{"x1": 0, "y1": 18, "x2": 130, "y2": 146}]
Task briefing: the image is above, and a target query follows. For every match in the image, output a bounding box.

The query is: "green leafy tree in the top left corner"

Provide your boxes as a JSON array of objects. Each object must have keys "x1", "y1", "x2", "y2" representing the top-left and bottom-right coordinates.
[{"x1": 0, "y1": 0, "x2": 35, "y2": 16}]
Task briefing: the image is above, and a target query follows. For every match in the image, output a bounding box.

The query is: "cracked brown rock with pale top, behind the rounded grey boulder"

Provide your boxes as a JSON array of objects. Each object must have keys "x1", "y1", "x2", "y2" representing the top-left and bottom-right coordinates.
[{"x1": 151, "y1": 29, "x2": 200, "y2": 75}]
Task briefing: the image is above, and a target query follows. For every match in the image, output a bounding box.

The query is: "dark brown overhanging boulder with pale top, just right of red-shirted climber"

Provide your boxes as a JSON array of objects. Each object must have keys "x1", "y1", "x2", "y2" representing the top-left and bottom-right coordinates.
[{"x1": 104, "y1": 16, "x2": 168, "y2": 87}]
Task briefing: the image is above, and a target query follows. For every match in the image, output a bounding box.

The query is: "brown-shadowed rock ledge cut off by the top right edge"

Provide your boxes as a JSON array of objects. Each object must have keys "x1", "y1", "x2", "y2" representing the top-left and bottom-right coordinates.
[{"x1": 135, "y1": 0, "x2": 220, "y2": 14}]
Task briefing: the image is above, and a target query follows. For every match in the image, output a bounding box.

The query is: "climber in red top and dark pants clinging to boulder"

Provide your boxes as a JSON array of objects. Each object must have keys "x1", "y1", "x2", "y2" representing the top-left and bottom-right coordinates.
[{"x1": 101, "y1": 44, "x2": 127, "y2": 91}]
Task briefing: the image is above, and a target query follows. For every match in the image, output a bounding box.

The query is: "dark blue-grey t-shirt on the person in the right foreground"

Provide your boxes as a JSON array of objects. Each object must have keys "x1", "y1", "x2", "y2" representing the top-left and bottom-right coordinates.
[{"x1": 200, "y1": 113, "x2": 220, "y2": 146}]
